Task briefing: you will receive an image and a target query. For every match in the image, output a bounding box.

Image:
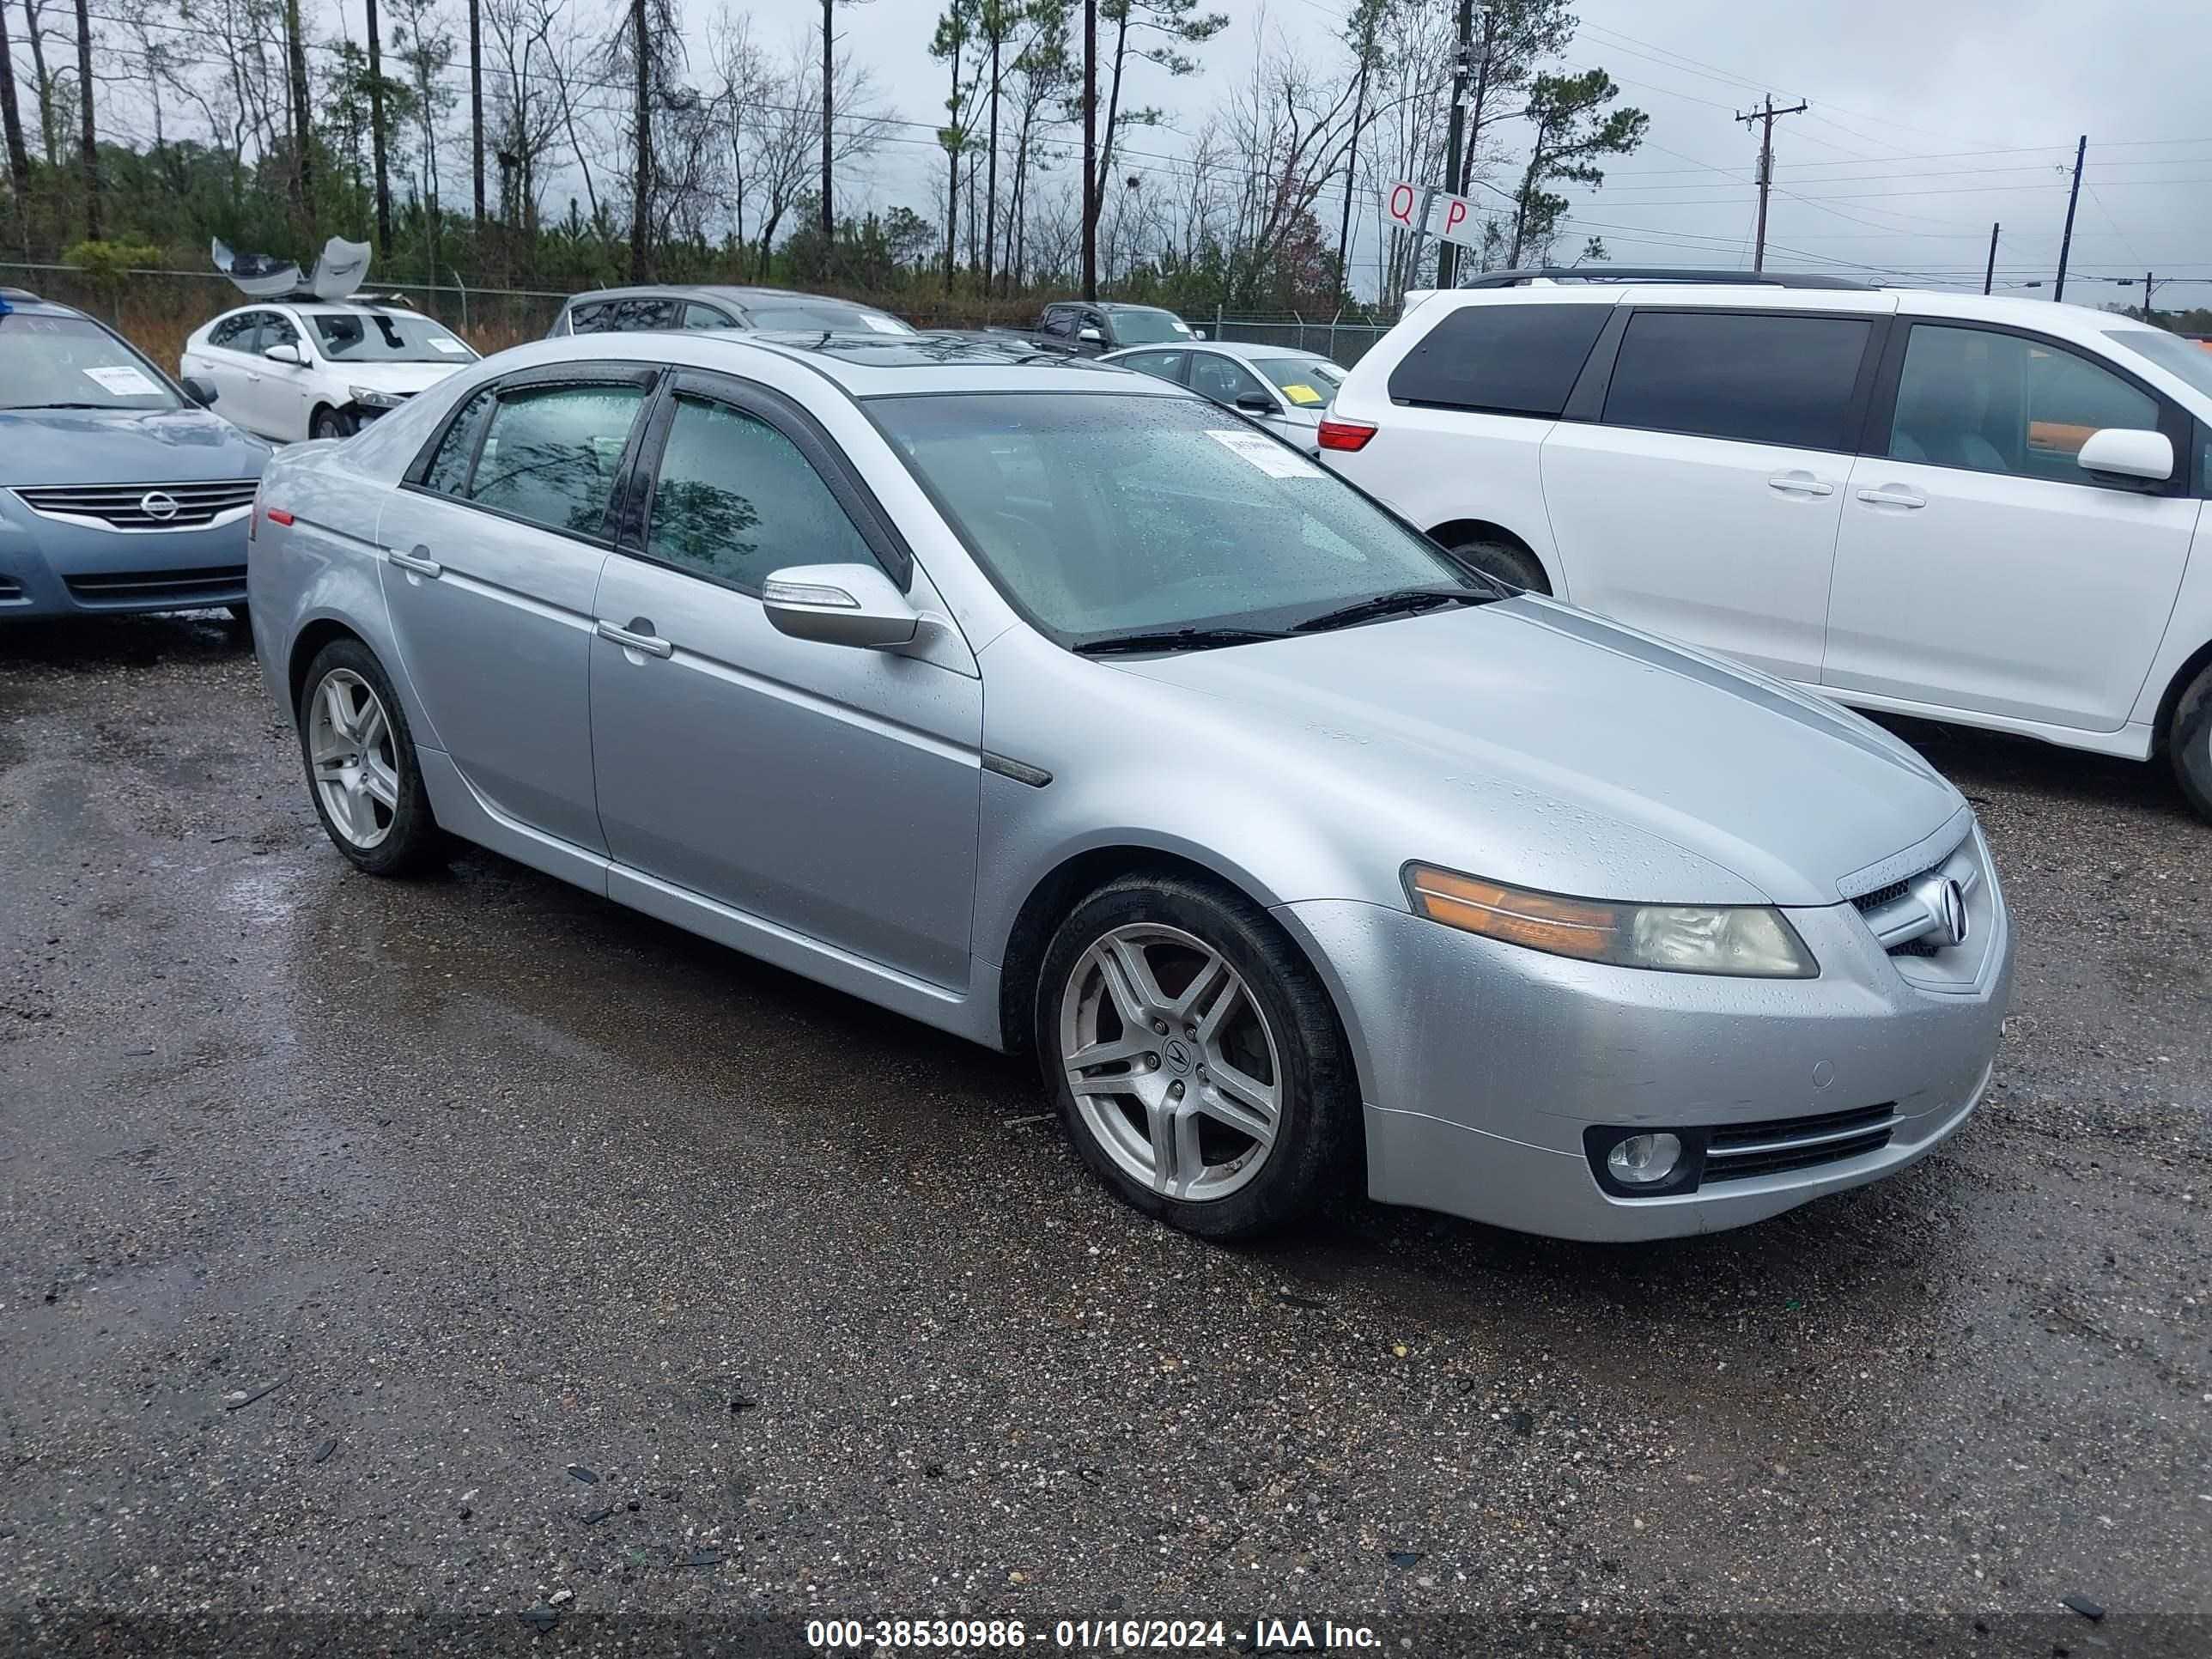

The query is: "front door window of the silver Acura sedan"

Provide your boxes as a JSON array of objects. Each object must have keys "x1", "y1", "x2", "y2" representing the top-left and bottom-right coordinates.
[{"x1": 646, "y1": 396, "x2": 876, "y2": 592}]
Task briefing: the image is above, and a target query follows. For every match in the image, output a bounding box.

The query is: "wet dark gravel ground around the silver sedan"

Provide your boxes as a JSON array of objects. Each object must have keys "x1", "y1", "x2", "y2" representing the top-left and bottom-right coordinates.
[{"x1": 0, "y1": 619, "x2": 2212, "y2": 1655}]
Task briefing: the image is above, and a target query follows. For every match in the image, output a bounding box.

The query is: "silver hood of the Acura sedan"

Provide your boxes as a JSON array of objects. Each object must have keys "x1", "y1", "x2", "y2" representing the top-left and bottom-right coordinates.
[{"x1": 1124, "y1": 595, "x2": 1960, "y2": 905}]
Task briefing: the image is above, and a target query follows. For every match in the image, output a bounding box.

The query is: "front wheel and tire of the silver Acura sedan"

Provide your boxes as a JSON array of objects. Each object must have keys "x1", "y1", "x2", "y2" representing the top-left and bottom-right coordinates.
[{"x1": 1036, "y1": 876, "x2": 1360, "y2": 1239}]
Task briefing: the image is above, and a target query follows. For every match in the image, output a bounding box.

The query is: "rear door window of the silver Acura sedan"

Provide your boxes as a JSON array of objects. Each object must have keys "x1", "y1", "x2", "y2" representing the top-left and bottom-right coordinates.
[{"x1": 469, "y1": 385, "x2": 646, "y2": 535}]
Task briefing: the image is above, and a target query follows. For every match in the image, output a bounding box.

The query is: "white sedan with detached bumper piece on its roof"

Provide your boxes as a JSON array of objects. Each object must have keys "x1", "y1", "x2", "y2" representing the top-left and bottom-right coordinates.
[{"x1": 179, "y1": 301, "x2": 477, "y2": 442}]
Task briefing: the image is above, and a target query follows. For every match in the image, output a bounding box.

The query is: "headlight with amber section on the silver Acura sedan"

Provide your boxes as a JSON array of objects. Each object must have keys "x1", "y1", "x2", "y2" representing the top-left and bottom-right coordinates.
[{"x1": 1405, "y1": 865, "x2": 1820, "y2": 980}]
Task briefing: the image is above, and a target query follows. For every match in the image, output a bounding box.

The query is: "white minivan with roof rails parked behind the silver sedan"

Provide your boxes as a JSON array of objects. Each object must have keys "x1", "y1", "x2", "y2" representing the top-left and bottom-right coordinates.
[{"x1": 1321, "y1": 272, "x2": 2212, "y2": 817}]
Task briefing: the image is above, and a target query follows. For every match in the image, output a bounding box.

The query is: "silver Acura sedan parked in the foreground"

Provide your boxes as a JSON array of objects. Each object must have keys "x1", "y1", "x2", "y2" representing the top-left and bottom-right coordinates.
[{"x1": 248, "y1": 334, "x2": 2011, "y2": 1239}]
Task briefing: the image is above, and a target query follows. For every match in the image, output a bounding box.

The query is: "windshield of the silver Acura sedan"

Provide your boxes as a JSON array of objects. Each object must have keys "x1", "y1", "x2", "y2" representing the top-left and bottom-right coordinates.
[{"x1": 869, "y1": 392, "x2": 1486, "y2": 648}]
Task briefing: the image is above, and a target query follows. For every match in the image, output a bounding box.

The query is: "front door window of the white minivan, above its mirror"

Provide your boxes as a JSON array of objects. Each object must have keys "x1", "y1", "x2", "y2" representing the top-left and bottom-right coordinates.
[{"x1": 1889, "y1": 323, "x2": 2159, "y2": 484}]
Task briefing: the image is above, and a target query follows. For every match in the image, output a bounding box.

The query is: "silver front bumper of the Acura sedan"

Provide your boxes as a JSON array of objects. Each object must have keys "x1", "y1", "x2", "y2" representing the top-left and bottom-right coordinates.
[{"x1": 1276, "y1": 876, "x2": 2013, "y2": 1241}]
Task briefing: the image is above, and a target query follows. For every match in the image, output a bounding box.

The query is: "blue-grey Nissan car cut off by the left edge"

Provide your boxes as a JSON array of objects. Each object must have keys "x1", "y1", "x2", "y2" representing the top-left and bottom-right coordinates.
[{"x1": 0, "y1": 288, "x2": 270, "y2": 619}]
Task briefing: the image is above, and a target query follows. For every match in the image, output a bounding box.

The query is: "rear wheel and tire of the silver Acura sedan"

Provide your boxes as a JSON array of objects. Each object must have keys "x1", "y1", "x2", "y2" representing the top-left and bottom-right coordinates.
[{"x1": 299, "y1": 639, "x2": 442, "y2": 876}]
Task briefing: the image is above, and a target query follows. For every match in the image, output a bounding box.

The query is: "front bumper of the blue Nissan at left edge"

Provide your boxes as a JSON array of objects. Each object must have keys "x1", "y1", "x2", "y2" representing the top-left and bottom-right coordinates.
[{"x1": 0, "y1": 491, "x2": 248, "y2": 622}]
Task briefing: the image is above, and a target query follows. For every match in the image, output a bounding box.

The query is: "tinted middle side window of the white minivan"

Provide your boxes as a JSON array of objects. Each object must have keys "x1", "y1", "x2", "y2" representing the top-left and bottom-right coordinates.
[{"x1": 1606, "y1": 312, "x2": 1874, "y2": 452}]
